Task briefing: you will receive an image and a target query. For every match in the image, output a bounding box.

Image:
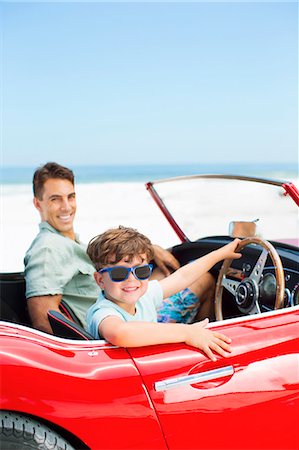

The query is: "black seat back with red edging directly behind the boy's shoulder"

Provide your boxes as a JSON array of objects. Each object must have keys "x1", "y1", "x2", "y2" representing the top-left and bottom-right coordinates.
[{"x1": 48, "y1": 309, "x2": 94, "y2": 341}]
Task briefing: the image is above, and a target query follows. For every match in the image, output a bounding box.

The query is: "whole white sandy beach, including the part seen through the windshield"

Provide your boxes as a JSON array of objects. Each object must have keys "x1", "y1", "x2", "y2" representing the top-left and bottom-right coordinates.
[{"x1": 0, "y1": 181, "x2": 298, "y2": 272}]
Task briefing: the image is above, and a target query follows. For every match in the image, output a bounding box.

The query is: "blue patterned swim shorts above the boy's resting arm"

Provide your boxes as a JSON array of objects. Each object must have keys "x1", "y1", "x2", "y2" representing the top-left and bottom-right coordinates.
[{"x1": 157, "y1": 288, "x2": 200, "y2": 323}]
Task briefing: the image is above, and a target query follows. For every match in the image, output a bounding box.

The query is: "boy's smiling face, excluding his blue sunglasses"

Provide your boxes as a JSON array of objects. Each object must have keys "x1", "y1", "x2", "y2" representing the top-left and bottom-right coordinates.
[{"x1": 95, "y1": 254, "x2": 149, "y2": 315}]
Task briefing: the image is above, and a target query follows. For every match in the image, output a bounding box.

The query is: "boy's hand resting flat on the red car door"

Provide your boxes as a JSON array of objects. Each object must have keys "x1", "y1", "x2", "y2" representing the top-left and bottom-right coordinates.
[{"x1": 185, "y1": 319, "x2": 231, "y2": 361}]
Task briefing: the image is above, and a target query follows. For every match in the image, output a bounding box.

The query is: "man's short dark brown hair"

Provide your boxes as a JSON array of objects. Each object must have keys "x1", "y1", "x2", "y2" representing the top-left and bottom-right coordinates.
[{"x1": 33, "y1": 162, "x2": 75, "y2": 200}]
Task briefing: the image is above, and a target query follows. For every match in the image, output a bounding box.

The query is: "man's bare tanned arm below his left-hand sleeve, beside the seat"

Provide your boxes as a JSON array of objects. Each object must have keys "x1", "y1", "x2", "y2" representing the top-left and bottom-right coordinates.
[{"x1": 27, "y1": 294, "x2": 62, "y2": 334}]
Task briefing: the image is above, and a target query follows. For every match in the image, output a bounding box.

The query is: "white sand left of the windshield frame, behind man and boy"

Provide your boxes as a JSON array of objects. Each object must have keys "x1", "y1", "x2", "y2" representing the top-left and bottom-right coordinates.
[{"x1": 0, "y1": 182, "x2": 179, "y2": 272}]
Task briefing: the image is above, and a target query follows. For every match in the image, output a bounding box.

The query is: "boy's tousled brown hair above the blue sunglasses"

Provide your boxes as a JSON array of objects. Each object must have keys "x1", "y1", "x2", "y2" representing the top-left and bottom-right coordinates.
[{"x1": 87, "y1": 225, "x2": 154, "y2": 270}]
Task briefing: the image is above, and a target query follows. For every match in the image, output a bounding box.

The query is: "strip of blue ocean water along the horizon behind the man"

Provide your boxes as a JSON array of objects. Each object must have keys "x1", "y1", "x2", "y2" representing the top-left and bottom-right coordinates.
[{"x1": 0, "y1": 163, "x2": 298, "y2": 185}]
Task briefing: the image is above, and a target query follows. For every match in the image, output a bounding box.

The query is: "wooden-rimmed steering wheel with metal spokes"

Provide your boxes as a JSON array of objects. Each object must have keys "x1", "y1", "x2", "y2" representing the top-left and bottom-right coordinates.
[{"x1": 215, "y1": 237, "x2": 285, "y2": 320}]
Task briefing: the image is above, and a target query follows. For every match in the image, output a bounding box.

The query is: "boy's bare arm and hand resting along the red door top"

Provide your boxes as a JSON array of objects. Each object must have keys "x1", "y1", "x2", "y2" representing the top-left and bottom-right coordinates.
[{"x1": 99, "y1": 316, "x2": 231, "y2": 361}]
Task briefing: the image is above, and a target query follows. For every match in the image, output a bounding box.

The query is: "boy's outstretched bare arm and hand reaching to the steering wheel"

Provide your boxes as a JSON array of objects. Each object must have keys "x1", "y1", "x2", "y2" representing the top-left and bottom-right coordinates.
[{"x1": 159, "y1": 239, "x2": 242, "y2": 298}]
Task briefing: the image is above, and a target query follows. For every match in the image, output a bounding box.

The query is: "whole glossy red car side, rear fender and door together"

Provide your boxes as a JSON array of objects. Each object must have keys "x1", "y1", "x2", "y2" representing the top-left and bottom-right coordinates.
[{"x1": 1, "y1": 308, "x2": 299, "y2": 450}]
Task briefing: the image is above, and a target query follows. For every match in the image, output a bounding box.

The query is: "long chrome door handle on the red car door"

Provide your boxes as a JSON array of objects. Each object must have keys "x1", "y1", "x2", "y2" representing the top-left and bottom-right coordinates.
[{"x1": 155, "y1": 366, "x2": 234, "y2": 392}]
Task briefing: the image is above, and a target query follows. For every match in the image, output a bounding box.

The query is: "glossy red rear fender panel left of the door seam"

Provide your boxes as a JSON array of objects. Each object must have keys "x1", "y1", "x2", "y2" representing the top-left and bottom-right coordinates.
[{"x1": 1, "y1": 326, "x2": 165, "y2": 450}]
